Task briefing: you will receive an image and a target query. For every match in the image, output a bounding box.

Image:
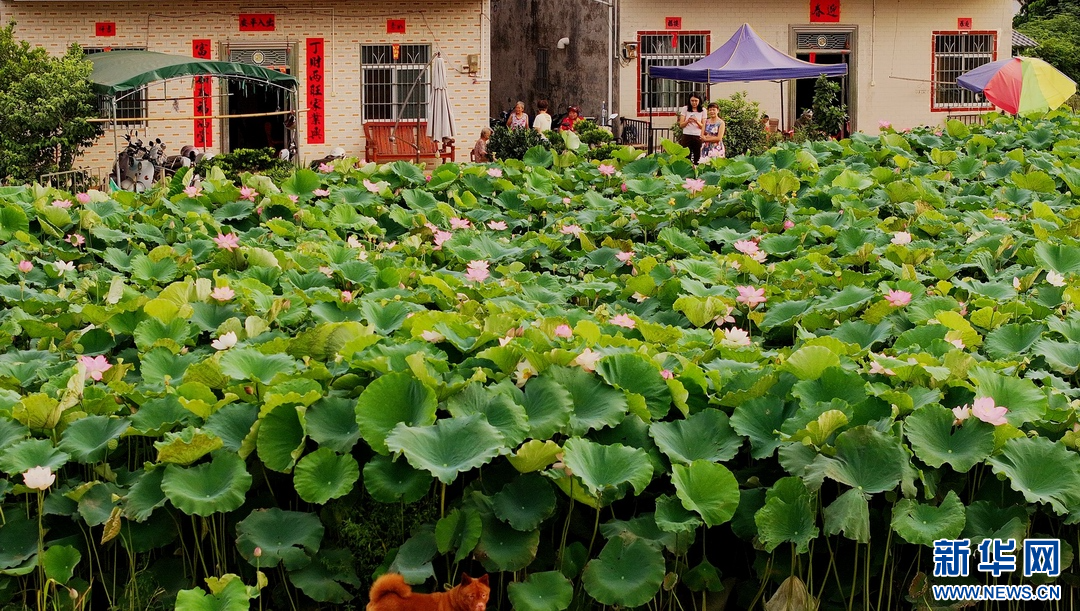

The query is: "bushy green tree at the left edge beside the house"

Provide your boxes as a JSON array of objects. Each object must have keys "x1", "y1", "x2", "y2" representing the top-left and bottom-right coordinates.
[{"x1": 0, "y1": 22, "x2": 103, "y2": 181}]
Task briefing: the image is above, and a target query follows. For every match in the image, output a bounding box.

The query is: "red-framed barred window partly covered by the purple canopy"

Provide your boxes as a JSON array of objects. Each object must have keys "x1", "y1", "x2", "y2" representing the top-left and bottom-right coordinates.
[{"x1": 637, "y1": 31, "x2": 708, "y2": 113}]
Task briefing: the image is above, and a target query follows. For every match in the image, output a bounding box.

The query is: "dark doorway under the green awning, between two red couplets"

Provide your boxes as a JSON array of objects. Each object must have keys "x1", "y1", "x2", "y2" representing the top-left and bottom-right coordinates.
[{"x1": 221, "y1": 44, "x2": 296, "y2": 152}]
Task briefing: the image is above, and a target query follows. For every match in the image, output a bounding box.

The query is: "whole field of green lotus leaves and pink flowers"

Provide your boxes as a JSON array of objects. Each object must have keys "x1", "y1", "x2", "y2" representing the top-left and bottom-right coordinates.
[{"x1": 0, "y1": 114, "x2": 1080, "y2": 611}]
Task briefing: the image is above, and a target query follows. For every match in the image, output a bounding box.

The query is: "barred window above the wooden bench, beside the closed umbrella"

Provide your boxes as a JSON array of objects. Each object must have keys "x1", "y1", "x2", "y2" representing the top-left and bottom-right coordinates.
[{"x1": 360, "y1": 44, "x2": 431, "y2": 121}]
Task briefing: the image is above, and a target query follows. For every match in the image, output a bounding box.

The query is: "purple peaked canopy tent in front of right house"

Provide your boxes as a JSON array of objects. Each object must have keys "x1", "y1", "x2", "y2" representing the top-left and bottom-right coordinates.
[{"x1": 649, "y1": 24, "x2": 848, "y2": 144}]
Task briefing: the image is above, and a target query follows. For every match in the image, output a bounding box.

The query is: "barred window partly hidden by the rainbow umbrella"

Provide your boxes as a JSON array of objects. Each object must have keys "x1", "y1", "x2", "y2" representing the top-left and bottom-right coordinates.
[{"x1": 930, "y1": 31, "x2": 998, "y2": 111}]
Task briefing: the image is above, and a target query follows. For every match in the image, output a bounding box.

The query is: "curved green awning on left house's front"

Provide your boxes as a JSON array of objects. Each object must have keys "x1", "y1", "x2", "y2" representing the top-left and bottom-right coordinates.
[{"x1": 87, "y1": 51, "x2": 297, "y2": 95}]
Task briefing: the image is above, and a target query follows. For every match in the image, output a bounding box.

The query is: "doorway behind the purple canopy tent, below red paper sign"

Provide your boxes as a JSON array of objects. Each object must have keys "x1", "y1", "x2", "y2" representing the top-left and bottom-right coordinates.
[{"x1": 787, "y1": 26, "x2": 858, "y2": 135}]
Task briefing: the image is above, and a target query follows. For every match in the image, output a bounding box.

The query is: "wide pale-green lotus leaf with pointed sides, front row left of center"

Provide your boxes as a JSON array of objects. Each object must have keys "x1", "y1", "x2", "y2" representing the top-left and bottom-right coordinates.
[{"x1": 387, "y1": 416, "x2": 505, "y2": 484}]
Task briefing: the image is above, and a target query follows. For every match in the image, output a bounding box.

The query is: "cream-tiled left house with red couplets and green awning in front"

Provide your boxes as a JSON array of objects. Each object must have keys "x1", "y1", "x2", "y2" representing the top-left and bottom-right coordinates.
[{"x1": 0, "y1": 0, "x2": 490, "y2": 177}]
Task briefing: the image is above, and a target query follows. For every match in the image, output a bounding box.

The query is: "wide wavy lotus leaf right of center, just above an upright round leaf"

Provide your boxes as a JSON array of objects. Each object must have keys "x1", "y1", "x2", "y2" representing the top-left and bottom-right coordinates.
[{"x1": 649, "y1": 409, "x2": 742, "y2": 464}]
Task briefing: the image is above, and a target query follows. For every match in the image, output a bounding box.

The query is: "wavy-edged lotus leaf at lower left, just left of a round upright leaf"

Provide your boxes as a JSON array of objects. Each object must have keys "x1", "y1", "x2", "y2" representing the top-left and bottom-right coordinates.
[{"x1": 161, "y1": 450, "x2": 252, "y2": 517}]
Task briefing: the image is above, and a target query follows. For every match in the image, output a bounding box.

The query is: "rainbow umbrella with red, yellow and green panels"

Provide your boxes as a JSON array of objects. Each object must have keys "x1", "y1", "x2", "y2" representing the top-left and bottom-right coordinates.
[{"x1": 956, "y1": 57, "x2": 1077, "y2": 114}]
